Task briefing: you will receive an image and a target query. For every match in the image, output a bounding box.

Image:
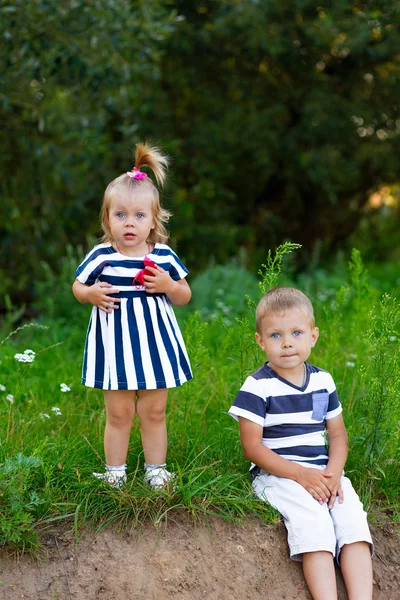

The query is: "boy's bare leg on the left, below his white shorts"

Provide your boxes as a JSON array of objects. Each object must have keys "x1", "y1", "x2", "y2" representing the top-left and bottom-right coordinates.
[{"x1": 303, "y1": 552, "x2": 337, "y2": 600}]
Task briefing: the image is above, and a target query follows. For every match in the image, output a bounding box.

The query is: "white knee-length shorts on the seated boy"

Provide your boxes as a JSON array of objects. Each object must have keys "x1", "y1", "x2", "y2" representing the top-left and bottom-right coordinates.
[{"x1": 253, "y1": 474, "x2": 373, "y2": 563}]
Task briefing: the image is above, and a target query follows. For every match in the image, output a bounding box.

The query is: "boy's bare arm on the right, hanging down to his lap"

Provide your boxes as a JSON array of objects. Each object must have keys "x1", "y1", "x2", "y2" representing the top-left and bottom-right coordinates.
[{"x1": 326, "y1": 415, "x2": 348, "y2": 508}]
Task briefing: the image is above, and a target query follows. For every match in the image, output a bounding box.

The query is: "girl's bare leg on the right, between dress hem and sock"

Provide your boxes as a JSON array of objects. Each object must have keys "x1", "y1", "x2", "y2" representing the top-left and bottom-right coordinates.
[{"x1": 136, "y1": 388, "x2": 168, "y2": 465}]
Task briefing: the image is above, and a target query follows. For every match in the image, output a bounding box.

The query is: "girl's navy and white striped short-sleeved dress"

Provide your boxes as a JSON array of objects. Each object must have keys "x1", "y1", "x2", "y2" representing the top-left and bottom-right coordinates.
[{"x1": 76, "y1": 243, "x2": 193, "y2": 390}]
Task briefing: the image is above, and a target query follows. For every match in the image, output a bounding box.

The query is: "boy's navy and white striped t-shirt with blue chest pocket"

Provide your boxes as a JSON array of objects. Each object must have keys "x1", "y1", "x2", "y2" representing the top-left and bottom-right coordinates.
[{"x1": 229, "y1": 363, "x2": 342, "y2": 468}]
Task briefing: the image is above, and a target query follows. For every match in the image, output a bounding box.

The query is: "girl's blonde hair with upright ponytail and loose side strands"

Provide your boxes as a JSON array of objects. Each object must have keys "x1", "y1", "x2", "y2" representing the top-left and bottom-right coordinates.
[{"x1": 100, "y1": 142, "x2": 171, "y2": 244}]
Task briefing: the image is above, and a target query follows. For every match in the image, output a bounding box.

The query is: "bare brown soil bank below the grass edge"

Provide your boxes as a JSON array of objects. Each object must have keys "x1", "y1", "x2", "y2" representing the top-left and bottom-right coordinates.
[{"x1": 0, "y1": 515, "x2": 400, "y2": 600}]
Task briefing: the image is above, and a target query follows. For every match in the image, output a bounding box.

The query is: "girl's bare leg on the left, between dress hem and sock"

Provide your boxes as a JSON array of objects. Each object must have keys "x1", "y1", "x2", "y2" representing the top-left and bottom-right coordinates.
[{"x1": 104, "y1": 390, "x2": 137, "y2": 466}]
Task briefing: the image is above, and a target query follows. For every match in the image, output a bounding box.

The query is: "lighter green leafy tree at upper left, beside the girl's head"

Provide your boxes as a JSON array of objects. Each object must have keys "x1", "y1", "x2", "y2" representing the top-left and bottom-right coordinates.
[{"x1": 0, "y1": 0, "x2": 175, "y2": 302}]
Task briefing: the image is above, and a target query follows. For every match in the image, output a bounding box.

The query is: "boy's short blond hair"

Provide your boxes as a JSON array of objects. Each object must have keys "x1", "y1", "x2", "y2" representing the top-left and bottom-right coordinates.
[{"x1": 256, "y1": 286, "x2": 315, "y2": 333}]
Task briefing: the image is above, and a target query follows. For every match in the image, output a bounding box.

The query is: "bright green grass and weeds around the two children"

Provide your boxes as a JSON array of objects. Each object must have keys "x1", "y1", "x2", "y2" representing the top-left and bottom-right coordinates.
[{"x1": 0, "y1": 247, "x2": 400, "y2": 550}]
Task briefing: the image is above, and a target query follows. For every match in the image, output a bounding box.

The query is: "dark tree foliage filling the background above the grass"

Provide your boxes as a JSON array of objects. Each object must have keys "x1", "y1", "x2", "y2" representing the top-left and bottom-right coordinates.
[{"x1": 0, "y1": 0, "x2": 400, "y2": 314}]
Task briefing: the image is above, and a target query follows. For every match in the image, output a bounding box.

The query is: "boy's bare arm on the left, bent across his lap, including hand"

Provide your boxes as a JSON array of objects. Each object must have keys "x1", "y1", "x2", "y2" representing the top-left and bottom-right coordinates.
[{"x1": 239, "y1": 417, "x2": 331, "y2": 504}]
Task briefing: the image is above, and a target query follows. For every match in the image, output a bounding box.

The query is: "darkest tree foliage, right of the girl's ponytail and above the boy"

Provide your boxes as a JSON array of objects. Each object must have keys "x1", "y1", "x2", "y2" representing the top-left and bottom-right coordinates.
[{"x1": 162, "y1": 0, "x2": 400, "y2": 264}]
